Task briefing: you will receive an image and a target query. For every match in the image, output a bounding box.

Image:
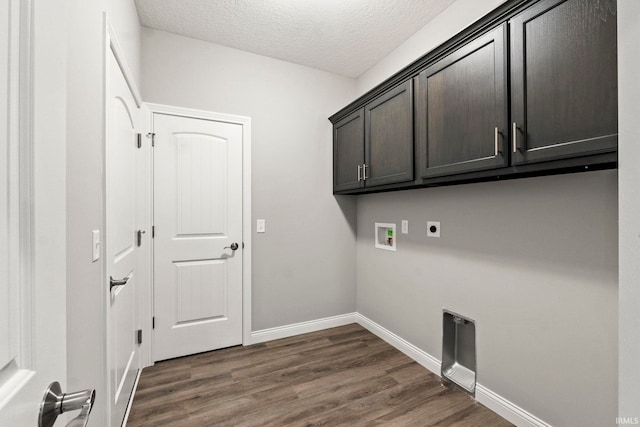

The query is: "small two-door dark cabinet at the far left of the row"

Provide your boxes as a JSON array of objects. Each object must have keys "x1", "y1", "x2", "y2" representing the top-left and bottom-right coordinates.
[{"x1": 333, "y1": 80, "x2": 414, "y2": 192}]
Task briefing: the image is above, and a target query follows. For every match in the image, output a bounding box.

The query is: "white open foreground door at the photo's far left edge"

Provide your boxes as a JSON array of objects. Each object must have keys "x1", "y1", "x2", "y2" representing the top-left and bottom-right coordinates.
[{"x1": 0, "y1": 0, "x2": 68, "y2": 426}]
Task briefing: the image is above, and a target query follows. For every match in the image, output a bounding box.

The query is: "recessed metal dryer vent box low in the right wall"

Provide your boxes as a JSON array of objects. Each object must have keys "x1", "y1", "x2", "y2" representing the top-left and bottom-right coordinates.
[{"x1": 441, "y1": 310, "x2": 476, "y2": 395}]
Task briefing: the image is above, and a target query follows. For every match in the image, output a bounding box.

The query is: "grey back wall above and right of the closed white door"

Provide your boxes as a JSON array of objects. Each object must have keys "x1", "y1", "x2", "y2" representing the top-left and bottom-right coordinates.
[{"x1": 142, "y1": 28, "x2": 355, "y2": 331}]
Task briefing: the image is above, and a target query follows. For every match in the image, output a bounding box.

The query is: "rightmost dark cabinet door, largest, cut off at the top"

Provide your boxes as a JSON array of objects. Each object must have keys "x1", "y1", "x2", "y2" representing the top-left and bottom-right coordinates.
[{"x1": 510, "y1": 0, "x2": 618, "y2": 164}]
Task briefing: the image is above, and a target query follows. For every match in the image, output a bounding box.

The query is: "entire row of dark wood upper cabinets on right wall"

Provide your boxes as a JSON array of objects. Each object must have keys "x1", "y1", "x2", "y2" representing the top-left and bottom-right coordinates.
[{"x1": 330, "y1": 0, "x2": 618, "y2": 194}]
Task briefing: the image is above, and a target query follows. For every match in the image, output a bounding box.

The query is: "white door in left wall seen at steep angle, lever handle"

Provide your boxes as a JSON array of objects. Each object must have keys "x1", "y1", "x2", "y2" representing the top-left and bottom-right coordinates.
[{"x1": 105, "y1": 51, "x2": 144, "y2": 427}]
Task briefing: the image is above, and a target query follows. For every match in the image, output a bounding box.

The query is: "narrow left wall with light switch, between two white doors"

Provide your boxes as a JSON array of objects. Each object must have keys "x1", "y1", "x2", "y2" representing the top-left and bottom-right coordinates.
[{"x1": 66, "y1": 0, "x2": 140, "y2": 426}]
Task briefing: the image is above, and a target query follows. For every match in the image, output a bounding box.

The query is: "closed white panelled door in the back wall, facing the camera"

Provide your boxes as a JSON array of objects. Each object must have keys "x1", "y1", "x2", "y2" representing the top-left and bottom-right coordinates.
[{"x1": 153, "y1": 113, "x2": 242, "y2": 360}]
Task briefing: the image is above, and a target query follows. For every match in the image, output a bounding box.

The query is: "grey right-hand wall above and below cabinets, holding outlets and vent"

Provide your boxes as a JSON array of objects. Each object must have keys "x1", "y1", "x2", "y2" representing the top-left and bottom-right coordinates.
[{"x1": 357, "y1": 0, "x2": 620, "y2": 426}]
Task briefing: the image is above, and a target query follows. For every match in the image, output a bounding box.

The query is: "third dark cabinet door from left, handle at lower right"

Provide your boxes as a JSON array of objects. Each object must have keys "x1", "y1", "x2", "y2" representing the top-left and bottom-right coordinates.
[{"x1": 416, "y1": 24, "x2": 508, "y2": 178}]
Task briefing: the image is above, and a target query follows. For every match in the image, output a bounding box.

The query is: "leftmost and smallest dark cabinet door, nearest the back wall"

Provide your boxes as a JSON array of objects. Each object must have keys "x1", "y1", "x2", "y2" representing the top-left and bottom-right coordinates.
[{"x1": 333, "y1": 109, "x2": 364, "y2": 192}]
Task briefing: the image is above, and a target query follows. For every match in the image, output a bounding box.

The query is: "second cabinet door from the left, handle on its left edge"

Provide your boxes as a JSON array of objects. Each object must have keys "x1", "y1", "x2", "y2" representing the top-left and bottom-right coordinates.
[{"x1": 364, "y1": 80, "x2": 413, "y2": 187}]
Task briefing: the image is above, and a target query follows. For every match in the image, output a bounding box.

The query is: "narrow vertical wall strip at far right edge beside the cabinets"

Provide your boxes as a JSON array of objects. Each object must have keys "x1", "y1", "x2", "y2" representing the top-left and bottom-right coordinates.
[{"x1": 618, "y1": 0, "x2": 640, "y2": 419}]
